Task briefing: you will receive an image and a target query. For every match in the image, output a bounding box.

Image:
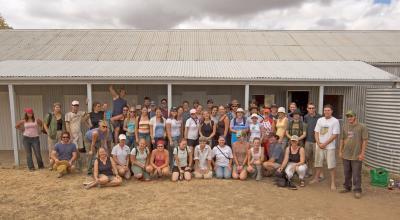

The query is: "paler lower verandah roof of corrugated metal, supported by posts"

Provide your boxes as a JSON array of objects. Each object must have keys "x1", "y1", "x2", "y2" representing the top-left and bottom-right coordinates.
[{"x1": 0, "y1": 60, "x2": 400, "y2": 83}]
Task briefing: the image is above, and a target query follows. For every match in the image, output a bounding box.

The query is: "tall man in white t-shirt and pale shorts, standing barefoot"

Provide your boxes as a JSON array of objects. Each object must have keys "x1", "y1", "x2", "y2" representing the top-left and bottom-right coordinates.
[{"x1": 310, "y1": 105, "x2": 340, "y2": 190}]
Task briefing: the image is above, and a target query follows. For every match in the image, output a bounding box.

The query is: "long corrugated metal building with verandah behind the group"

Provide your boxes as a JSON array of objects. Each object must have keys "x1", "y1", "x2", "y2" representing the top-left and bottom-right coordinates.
[{"x1": 0, "y1": 30, "x2": 400, "y2": 173}]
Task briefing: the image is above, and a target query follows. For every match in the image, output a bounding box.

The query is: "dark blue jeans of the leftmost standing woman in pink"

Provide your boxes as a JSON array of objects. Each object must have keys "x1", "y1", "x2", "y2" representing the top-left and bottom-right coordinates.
[{"x1": 22, "y1": 136, "x2": 44, "y2": 170}]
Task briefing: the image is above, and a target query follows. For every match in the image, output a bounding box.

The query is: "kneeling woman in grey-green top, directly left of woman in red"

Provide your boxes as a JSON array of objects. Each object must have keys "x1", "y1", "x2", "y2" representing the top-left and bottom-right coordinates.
[{"x1": 131, "y1": 138, "x2": 150, "y2": 181}]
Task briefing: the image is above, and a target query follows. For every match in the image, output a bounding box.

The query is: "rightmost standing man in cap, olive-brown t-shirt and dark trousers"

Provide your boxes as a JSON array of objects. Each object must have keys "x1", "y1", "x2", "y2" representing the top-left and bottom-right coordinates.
[{"x1": 339, "y1": 110, "x2": 368, "y2": 199}]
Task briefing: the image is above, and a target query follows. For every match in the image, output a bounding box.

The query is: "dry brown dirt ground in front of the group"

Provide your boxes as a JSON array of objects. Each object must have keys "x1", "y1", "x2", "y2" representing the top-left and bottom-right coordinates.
[{"x1": 0, "y1": 151, "x2": 400, "y2": 220}]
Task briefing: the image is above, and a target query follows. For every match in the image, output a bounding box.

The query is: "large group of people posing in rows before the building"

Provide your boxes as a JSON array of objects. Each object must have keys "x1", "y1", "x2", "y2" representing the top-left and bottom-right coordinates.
[{"x1": 16, "y1": 86, "x2": 368, "y2": 198}]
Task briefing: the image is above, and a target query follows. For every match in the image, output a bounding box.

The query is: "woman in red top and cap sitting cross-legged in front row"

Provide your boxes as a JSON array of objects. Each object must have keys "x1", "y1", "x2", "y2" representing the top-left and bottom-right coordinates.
[{"x1": 146, "y1": 140, "x2": 169, "y2": 177}]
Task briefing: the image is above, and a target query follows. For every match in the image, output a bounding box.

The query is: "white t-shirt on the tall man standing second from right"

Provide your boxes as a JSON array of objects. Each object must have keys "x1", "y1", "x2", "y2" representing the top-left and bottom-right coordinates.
[{"x1": 314, "y1": 117, "x2": 340, "y2": 149}]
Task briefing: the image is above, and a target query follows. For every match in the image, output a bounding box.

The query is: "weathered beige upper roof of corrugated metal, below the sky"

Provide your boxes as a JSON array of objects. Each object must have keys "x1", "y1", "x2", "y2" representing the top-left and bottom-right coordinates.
[{"x1": 0, "y1": 30, "x2": 400, "y2": 63}]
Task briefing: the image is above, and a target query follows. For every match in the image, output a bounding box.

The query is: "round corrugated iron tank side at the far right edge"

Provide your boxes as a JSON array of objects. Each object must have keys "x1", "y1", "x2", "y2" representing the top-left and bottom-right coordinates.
[{"x1": 366, "y1": 89, "x2": 400, "y2": 174}]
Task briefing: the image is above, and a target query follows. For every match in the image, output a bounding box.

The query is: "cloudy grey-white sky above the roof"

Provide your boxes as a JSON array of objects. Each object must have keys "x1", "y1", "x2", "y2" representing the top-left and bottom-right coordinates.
[{"x1": 0, "y1": 0, "x2": 400, "y2": 30}]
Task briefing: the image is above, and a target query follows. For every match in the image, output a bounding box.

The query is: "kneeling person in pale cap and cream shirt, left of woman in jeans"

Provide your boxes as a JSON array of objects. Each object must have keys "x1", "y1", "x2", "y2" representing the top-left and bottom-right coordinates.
[{"x1": 194, "y1": 137, "x2": 213, "y2": 179}]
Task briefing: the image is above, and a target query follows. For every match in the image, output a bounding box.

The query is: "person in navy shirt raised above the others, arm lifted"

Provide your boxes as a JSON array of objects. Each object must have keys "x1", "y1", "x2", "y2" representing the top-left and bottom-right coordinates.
[{"x1": 109, "y1": 86, "x2": 128, "y2": 143}]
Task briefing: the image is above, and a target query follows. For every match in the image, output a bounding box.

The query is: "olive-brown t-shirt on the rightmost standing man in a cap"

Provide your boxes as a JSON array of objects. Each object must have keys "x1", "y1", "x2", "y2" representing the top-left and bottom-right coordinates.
[{"x1": 341, "y1": 123, "x2": 368, "y2": 160}]
